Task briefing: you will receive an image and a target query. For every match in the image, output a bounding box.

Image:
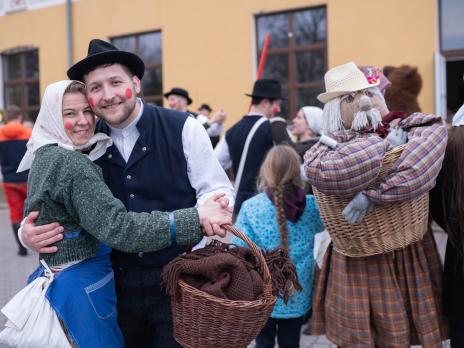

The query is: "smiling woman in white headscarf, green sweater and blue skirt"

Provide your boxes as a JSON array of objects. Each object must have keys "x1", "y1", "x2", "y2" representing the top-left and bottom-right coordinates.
[{"x1": 0, "y1": 81, "x2": 231, "y2": 347}]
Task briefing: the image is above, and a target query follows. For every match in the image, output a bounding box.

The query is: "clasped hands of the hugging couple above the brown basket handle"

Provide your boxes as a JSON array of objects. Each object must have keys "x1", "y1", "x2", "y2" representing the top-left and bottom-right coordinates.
[{"x1": 198, "y1": 193, "x2": 232, "y2": 237}]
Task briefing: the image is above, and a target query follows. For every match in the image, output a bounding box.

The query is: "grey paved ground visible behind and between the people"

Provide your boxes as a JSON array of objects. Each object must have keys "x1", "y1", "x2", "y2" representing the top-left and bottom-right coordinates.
[{"x1": 0, "y1": 196, "x2": 450, "y2": 348}]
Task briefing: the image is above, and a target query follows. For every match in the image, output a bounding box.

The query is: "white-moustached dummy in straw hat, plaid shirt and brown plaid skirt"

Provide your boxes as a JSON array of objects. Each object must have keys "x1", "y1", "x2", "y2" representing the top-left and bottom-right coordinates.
[{"x1": 305, "y1": 63, "x2": 447, "y2": 348}]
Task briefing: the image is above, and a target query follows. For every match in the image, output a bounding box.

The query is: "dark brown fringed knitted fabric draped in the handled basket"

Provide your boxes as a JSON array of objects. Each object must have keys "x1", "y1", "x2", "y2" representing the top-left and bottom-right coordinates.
[{"x1": 162, "y1": 241, "x2": 301, "y2": 301}]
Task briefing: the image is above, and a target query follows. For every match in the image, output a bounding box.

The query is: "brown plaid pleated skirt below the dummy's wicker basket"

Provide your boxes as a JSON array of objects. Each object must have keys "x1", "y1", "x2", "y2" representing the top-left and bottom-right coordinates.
[{"x1": 311, "y1": 231, "x2": 447, "y2": 348}]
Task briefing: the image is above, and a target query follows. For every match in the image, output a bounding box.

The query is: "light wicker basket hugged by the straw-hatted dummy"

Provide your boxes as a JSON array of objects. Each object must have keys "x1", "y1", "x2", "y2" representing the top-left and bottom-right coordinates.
[{"x1": 313, "y1": 145, "x2": 429, "y2": 257}]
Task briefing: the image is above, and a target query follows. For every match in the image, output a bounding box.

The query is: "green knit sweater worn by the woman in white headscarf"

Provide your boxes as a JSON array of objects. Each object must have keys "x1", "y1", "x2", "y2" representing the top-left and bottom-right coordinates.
[{"x1": 24, "y1": 145, "x2": 202, "y2": 266}]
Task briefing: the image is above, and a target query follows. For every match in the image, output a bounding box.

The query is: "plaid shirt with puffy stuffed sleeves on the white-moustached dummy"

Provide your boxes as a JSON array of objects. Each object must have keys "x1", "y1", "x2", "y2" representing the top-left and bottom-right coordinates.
[{"x1": 304, "y1": 113, "x2": 447, "y2": 204}]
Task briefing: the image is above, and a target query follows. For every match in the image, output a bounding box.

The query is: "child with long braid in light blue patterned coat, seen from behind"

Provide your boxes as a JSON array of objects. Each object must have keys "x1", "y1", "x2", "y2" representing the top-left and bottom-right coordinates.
[{"x1": 231, "y1": 145, "x2": 324, "y2": 348}]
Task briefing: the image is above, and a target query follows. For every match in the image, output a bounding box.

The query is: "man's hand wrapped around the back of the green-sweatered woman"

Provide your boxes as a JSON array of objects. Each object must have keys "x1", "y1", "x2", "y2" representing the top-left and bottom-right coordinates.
[{"x1": 21, "y1": 211, "x2": 64, "y2": 254}]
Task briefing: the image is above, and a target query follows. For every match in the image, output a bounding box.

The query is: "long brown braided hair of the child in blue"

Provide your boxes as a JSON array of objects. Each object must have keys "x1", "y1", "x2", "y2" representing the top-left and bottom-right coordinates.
[{"x1": 258, "y1": 145, "x2": 304, "y2": 252}]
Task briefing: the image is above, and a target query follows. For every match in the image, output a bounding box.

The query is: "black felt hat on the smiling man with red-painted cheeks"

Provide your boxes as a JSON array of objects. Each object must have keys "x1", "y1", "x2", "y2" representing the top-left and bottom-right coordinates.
[{"x1": 67, "y1": 39, "x2": 145, "y2": 81}]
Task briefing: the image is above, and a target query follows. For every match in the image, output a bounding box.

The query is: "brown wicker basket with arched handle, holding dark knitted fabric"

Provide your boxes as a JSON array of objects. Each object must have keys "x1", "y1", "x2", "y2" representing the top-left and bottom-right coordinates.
[{"x1": 171, "y1": 226, "x2": 276, "y2": 348}]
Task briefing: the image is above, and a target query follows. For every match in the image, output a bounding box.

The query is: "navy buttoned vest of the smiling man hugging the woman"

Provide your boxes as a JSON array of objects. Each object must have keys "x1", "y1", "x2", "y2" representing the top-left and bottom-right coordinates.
[{"x1": 96, "y1": 104, "x2": 196, "y2": 268}]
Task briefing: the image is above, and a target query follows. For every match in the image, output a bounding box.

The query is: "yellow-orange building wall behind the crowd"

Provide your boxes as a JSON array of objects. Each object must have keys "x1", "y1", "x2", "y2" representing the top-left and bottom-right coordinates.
[{"x1": 0, "y1": 0, "x2": 437, "y2": 126}]
